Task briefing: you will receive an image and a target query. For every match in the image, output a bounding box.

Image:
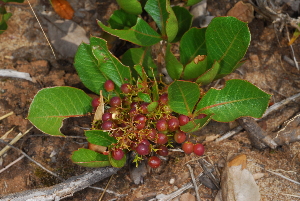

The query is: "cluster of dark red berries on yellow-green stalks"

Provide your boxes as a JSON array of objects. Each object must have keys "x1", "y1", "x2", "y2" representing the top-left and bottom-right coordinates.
[{"x1": 92, "y1": 80, "x2": 204, "y2": 168}]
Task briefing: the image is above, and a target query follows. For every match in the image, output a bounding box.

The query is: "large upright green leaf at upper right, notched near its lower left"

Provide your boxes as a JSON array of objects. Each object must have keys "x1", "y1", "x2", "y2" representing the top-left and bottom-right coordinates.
[{"x1": 205, "y1": 17, "x2": 251, "y2": 75}]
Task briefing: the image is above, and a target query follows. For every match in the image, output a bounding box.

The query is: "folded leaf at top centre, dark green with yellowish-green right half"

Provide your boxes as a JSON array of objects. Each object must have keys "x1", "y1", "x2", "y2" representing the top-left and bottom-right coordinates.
[{"x1": 144, "y1": 0, "x2": 178, "y2": 42}]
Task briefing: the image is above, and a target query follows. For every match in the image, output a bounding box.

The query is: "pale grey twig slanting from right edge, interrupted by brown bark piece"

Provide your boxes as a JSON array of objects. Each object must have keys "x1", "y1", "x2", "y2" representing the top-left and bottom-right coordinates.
[{"x1": 216, "y1": 93, "x2": 300, "y2": 142}]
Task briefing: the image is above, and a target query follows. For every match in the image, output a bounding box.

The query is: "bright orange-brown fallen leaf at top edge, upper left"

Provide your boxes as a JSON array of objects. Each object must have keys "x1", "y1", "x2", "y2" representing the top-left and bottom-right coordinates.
[{"x1": 51, "y1": 0, "x2": 74, "y2": 20}]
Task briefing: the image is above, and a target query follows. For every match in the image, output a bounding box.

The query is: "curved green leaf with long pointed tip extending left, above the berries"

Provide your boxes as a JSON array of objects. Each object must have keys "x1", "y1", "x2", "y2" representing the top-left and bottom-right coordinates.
[{"x1": 98, "y1": 18, "x2": 162, "y2": 46}]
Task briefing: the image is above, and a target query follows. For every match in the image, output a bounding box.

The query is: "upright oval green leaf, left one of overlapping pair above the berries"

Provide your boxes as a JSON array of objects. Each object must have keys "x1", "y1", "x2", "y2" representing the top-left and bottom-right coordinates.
[{"x1": 74, "y1": 43, "x2": 108, "y2": 97}]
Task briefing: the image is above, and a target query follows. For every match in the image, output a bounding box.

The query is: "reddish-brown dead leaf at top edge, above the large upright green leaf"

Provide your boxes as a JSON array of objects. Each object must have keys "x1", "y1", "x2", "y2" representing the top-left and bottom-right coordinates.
[{"x1": 227, "y1": 1, "x2": 254, "y2": 23}]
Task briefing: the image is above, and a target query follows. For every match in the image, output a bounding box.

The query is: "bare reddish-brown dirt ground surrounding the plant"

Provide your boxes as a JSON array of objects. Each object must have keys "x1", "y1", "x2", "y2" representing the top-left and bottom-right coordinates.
[{"x1": 0, "y1": 0, "x2": 300, "y2": 201}]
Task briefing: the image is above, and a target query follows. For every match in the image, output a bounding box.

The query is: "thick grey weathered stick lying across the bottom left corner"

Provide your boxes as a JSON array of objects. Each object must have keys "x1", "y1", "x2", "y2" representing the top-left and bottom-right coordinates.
[{"x1": 0, "y1": 167, "x2": 120, "y2": 201}]
